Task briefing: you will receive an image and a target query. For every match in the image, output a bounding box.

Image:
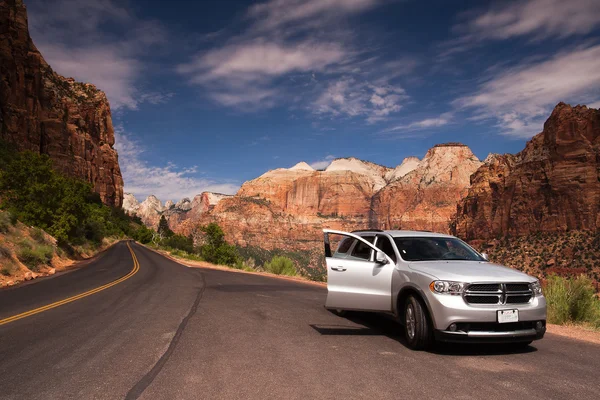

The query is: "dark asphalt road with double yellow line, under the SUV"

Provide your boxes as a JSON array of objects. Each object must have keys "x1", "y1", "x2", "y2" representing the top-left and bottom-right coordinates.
[{"x1": 0, "y1": 242, "x2": 600, "y2": 400}]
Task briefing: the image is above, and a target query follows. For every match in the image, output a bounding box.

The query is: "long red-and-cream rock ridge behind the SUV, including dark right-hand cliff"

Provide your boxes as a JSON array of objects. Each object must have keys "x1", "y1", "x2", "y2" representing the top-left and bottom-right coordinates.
[{"x1": 123, "y1": 103, "x2": 600, "y2": 258}]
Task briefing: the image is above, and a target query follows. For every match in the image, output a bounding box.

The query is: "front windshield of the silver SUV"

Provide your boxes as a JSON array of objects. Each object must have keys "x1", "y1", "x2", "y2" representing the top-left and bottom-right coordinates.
[{"x1": 394, "y1": 237, "x2": 485, "y2": 261}]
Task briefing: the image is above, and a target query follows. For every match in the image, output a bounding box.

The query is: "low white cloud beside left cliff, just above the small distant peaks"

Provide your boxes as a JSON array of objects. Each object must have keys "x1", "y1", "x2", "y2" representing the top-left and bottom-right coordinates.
[{"x1": 115, "y1": 127, "x2": 239, "y2": 201}]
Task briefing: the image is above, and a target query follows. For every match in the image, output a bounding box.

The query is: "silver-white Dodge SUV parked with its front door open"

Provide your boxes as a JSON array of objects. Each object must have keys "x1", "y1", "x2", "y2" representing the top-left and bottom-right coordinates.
[{"x1": 323, "y1": 229, "x2": 546, "y2": 349}]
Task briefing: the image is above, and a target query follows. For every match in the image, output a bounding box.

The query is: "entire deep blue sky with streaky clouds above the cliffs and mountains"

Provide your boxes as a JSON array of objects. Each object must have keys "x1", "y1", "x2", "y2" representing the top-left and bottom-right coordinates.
[{"x1": 26, "y1": 0, "x2": 600, "y2": 201}]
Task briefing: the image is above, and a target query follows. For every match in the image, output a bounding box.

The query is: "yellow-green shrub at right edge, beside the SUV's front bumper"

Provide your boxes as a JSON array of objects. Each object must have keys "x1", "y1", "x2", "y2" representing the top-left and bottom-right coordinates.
[{"x1": 544, "y1": 275, "x2": 600, "y2": 326}]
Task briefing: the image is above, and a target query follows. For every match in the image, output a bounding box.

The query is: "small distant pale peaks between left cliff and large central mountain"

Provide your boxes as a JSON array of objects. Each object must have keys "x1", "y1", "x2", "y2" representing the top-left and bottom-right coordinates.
[{"x1": 123, "y1": 192, "x2": 229, "y2": 234}]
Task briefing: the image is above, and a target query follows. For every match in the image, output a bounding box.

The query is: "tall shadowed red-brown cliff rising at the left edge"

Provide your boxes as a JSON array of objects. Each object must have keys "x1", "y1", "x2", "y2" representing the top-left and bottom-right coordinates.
[{"x1": 0, "y1": 0, "x2": 123, "y2": 207}]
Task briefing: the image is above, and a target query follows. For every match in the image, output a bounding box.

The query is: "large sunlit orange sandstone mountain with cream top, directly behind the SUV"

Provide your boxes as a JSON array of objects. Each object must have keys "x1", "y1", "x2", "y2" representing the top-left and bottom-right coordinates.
[{"x1": 186, "y1": 144, "x2": 481, "y2": 249}]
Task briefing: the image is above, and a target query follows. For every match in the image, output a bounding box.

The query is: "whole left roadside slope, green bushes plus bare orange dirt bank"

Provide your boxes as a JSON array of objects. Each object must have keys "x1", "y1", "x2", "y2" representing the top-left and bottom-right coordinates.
[{"x1": 0, "y1": 141, "x2": 152, "y2": 286}]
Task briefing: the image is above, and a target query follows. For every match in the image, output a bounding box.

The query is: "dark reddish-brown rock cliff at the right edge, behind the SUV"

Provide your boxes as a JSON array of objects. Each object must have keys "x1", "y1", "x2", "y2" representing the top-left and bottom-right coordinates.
[{"x1": 454, "y1": 103, "x2": 600, "y2": 239}]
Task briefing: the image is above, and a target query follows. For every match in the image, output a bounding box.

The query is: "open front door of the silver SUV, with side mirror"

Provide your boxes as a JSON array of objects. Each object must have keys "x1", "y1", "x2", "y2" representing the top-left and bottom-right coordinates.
[{"x1": 323, "y1": 229, "x2": 396, "y2": 311}]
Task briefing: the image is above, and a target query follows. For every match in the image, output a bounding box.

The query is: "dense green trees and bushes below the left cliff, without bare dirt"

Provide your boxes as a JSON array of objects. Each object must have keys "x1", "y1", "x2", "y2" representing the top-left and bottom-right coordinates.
[{"x1": 0, "y1": 142, "x2": 147, "y2": 248}]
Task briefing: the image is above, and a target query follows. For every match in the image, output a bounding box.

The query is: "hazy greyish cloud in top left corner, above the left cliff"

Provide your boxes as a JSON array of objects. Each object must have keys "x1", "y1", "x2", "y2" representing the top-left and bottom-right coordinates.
[{"x1": 28, "y1": 0, "x2": 168, "y2": 109}]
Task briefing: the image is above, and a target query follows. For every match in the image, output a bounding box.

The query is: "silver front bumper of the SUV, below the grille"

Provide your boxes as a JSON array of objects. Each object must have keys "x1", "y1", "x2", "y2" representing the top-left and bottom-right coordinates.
[{"x1": 427, "y1": 293, "x2": 546, "y2": 342}]
